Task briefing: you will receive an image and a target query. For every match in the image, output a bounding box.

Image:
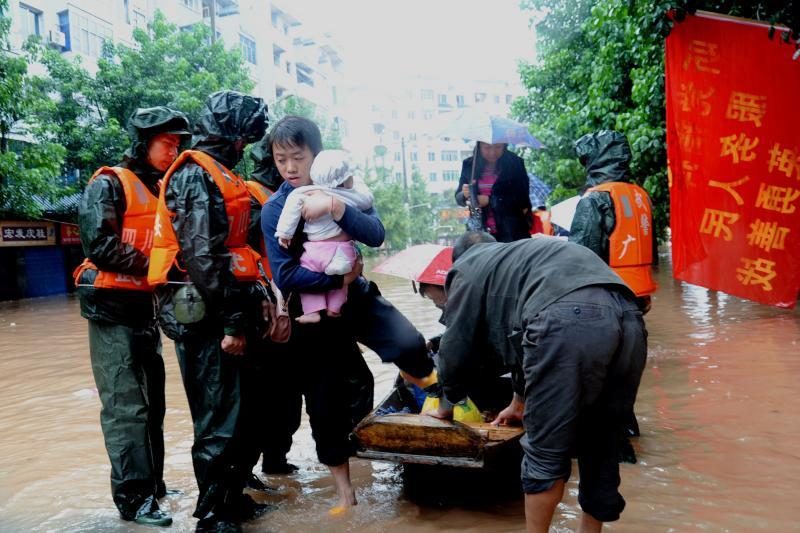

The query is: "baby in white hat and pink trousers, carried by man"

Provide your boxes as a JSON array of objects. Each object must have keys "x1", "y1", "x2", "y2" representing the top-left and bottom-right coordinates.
[{"x1": 275, "y1": 150, "x2": 373, "y2": 323}]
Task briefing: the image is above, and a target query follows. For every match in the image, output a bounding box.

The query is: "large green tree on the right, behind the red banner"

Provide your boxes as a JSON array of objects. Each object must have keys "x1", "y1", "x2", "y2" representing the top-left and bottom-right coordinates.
[{"x1": 512, "y1": 0, "x2": 800, "y2": 238}]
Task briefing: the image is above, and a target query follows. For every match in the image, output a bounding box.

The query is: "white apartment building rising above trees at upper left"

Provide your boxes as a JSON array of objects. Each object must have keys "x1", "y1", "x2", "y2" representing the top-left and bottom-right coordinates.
[{"x1": 9, "y1": 0, "x2": 344, "y2": 124}]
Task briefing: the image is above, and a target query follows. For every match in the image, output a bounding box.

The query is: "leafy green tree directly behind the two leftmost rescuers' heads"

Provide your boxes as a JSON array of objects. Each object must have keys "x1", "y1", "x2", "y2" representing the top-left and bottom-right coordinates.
[{"x1": 29, "y1": 11, "x2": 254, "y2": 179}]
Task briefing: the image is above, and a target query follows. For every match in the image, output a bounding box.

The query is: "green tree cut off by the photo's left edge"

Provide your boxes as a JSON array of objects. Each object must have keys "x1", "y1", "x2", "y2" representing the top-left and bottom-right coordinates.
[{"x1": 0, "y1": 0, "x2": 65, "y2": 217}]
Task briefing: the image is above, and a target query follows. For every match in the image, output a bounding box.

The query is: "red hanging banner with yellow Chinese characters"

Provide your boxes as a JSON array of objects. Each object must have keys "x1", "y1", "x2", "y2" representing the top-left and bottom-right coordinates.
[{"x1": 665, "y1": 12, "x2": 800, "y2": 308}]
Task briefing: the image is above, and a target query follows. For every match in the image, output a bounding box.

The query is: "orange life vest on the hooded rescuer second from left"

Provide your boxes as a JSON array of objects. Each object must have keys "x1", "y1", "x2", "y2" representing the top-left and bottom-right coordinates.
[{"x1": 147, "y1": 150, "x2": 261, "y2": 285}]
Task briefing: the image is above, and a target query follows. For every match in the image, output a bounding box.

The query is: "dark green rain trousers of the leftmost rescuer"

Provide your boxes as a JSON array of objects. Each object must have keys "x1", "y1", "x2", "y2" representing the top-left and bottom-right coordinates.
[{"x1": 89, "y1": 320, "x2": 165, "y2": 520}]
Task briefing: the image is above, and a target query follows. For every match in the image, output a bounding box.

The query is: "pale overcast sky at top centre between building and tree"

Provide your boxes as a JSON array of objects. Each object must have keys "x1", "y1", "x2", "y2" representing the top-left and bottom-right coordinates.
[{"x1": 287, "y1": 0, "x2": 534, "y2": 82}]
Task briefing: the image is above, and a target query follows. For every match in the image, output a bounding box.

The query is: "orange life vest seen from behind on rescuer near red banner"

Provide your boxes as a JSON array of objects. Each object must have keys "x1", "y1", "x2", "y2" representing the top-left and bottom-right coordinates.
[{"x1": 587, "y1": 181, "x2": 657, "y2": 296}]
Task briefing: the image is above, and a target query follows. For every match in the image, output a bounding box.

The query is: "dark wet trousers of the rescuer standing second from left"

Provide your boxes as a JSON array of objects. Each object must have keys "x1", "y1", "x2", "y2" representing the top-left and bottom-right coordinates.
[{"x1": 175, "y1": 325, "x2": 258, "y2": 521}]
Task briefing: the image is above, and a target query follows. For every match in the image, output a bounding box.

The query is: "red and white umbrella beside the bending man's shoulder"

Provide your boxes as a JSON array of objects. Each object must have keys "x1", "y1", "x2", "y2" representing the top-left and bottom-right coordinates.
[{"x1": 372, "y1": 244, "x2": 453, "y2": 286}]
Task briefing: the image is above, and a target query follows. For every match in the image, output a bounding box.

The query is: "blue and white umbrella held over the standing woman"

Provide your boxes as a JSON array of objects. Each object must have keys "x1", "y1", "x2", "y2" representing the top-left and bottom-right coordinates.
[{"x1": 439, "y1": 109, "x2": 544, "y2": 148}]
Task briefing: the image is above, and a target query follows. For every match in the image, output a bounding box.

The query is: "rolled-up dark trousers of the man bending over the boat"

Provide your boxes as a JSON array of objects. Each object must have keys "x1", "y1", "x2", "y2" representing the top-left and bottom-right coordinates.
[{"x1": 522, "y1": 286, "x2": 647, "y2": 522}]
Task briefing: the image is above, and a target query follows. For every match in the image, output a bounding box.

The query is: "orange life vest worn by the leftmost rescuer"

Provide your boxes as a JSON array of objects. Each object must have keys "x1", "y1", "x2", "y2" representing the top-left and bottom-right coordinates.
[{"x1": 73, "y1": 167, "x2": 157, "y2": 292}]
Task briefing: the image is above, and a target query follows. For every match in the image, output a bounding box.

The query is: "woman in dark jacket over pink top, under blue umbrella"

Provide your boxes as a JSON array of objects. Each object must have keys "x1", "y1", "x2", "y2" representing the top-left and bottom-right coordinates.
[{"x1": 456, "y1": 141, "x2": 531, "y2": 242}]
